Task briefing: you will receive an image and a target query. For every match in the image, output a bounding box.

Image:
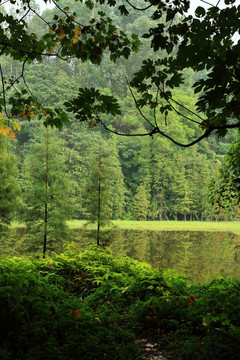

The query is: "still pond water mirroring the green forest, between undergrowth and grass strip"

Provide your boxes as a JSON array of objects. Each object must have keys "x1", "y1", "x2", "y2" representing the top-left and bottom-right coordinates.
[{"x1": 0, "y1": 229, "x2": 240, "y2": 283}]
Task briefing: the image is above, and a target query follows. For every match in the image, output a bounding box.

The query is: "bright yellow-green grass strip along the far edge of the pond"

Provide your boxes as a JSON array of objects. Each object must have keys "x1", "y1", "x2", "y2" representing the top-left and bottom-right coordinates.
[{"x1": 68, "y1": 220, "x2": 240, "y2": 235}]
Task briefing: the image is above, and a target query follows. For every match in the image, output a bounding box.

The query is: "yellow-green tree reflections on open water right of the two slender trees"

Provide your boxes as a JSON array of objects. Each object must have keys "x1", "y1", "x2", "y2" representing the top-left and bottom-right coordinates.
[{"x1": 109, "y1": 230, "x2": 240, "y2": 282}]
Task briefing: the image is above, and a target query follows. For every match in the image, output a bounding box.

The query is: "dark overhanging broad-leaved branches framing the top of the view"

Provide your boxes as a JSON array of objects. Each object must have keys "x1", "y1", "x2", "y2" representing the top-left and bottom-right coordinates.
[{"x1": 0, "y1": 0, "x2": 240, "y2": 147}]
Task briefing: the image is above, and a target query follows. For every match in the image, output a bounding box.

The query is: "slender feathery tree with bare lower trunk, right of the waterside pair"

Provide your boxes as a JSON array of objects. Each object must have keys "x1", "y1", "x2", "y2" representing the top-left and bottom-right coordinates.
[{"x1": 84, "y1": 134, "x2": 124, "y2": 245}]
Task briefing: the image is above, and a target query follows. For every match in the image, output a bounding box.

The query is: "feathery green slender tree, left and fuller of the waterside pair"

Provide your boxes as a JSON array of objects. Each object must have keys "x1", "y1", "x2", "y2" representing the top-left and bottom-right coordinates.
[{"x1": 22, "y1": 128, "x2": 72, "y2": 256}]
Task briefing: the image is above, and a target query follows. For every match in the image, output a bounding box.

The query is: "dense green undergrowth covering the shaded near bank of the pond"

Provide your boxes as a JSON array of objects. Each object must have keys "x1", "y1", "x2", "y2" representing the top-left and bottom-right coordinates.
[{"x1": 0, "y1": 248, "x2": 240, "y2": 360}]
